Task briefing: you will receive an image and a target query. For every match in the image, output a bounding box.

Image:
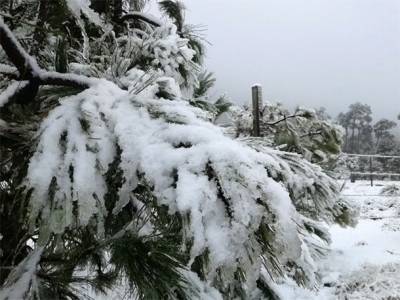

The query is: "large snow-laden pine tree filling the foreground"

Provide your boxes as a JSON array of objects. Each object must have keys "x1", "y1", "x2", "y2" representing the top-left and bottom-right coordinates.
[{"x1": 0, "y1": 0, "x2": 356, "y2": 299}]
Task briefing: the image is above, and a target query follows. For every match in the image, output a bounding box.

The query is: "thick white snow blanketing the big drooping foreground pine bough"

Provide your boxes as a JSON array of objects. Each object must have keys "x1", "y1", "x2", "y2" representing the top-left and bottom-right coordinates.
[{"x1": 27, "y1": 79, "x2": 326, "y2": 287}]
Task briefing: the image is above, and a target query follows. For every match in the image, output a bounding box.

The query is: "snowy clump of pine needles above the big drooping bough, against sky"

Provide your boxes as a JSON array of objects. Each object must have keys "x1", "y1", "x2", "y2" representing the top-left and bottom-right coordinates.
[{"x1": 103, "y1": 23, "x2": 200, "y2": 89}]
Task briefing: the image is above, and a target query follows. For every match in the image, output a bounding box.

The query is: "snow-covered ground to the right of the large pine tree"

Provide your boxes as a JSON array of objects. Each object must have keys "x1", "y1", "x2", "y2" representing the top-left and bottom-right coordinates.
[{"x1": 277, "y1": 181, "x2": 400, "y2": 300}]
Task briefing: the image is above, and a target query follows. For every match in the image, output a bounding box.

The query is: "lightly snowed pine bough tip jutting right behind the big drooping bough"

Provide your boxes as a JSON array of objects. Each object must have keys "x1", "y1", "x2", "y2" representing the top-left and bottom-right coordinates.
[{"x1": 244, "y1": 138, "x2": 357, "y2": 223}]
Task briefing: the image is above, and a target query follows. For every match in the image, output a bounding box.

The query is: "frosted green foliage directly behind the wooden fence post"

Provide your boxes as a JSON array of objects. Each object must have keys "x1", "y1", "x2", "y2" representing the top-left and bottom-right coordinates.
[{"x1": 217, "y1": 103, "x2": 342, "y2": 165}]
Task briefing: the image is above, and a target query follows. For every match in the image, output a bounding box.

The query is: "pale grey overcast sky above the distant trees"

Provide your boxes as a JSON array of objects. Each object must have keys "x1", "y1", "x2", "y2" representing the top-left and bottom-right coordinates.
[{"x1": 179, "y1": 0, "x2": 400, "y2": 119}]
